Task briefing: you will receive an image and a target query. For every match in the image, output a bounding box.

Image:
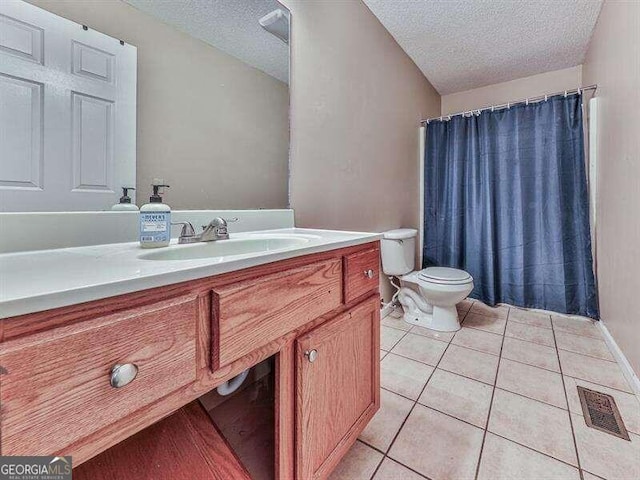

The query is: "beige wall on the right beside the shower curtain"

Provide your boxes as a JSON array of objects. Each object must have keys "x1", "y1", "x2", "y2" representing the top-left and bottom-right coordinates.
[{"x1": 583, "y1": 0, "x2": 640, "y2": 373}]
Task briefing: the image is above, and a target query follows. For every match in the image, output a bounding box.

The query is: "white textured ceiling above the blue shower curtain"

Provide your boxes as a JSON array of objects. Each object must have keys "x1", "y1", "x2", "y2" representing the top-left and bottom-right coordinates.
[{"x1": 364, "y1": 0, "x2": 602, "y2": 95}]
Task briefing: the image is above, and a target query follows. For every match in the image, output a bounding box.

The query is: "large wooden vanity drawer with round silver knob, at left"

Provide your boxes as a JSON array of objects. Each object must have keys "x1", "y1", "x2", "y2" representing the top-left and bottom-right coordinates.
[{"x1": 0, "y1": 296, "x2": 197, "y2": 455}]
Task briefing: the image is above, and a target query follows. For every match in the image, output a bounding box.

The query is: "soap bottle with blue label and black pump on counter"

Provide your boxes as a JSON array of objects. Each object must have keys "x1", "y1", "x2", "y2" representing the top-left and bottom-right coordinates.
[{"x1": 140, "y1": 183, "x2": 171, "y2": 248}]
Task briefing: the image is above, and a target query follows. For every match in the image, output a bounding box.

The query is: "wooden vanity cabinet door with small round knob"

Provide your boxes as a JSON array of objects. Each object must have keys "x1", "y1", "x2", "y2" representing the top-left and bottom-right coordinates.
[{"x1": 296, "y1": 296, "x2": 380, "y2": 480}]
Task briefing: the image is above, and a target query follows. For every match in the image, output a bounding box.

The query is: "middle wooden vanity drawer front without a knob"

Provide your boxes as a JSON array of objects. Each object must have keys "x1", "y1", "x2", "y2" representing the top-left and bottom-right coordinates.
[{"x1": 212, "y1": 258, "x2": 342, "y2": 370}]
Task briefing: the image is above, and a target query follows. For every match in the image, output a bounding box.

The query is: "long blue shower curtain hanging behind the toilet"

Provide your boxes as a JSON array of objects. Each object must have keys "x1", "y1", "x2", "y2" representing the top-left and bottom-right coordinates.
[{"x1": 423, "y1": 95, "x2": 599, "y2": 319}]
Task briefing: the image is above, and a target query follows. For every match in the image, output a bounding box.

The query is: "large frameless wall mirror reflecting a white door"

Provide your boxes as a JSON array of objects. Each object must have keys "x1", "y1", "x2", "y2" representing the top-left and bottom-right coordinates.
[{"x1": 0, "y1": 0, "x2": 290, "y2": 212}]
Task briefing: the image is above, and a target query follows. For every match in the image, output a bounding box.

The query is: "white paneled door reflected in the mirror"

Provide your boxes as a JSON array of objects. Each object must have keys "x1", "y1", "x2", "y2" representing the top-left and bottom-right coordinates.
[{"x1": 0, "y1": 0, "x2": 137, "y2": 212}]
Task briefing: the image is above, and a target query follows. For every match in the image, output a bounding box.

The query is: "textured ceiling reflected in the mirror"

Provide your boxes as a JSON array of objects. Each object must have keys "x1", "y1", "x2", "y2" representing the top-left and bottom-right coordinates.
[{"x1": 125, "y1": 0, "x2": 289, "y2": 83}]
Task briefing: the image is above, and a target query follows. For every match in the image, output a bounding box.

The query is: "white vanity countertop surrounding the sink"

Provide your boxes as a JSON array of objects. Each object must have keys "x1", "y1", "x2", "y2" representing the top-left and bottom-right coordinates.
[{"x1": 0, "y1": 228, "x2": 382, "y2": 318}]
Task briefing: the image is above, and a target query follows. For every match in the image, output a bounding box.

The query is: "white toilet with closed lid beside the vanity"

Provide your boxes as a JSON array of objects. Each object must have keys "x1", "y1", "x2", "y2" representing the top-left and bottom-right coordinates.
[{"x1": 381, "y1": 228, "x2": 473, "y2": 332}]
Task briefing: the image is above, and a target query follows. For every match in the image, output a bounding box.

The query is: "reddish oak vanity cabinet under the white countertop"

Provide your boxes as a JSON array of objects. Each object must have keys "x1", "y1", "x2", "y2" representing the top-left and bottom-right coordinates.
[{"x1": 0, "y1": 242, "x2": 380, "y2": 480}]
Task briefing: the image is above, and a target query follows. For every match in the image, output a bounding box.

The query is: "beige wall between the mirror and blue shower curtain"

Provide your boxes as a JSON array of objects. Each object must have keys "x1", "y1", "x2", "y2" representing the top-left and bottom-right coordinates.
[{"x1": 283, "y1": 0, "x2": 440, "y2": 297}]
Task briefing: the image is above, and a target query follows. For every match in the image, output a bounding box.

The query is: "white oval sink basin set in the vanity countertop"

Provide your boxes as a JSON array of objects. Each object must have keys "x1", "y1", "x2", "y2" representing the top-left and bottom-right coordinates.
[{"x1": 138, "y1": 235, "x2": 309, "y2": 261}]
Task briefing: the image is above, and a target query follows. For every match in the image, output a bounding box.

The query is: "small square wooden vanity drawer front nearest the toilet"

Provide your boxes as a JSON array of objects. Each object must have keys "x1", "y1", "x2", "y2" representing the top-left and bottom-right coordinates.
[{"x1": 344, "y1": 247, "x2": 380, "y2": 303}]
